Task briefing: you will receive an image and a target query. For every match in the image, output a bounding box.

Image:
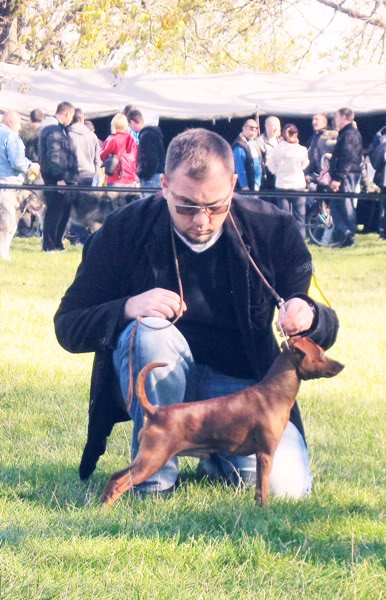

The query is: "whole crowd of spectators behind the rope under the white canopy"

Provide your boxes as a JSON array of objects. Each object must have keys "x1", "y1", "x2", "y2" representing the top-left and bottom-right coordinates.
[{"x1": 0, "y1": 102, "x2": 386, "y2": 251}]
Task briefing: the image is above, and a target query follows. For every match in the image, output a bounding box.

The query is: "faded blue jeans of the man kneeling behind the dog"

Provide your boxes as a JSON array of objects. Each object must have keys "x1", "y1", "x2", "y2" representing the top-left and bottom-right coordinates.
[{"x1": 113, "y1": 317, "x2": 311, "y2": 498}]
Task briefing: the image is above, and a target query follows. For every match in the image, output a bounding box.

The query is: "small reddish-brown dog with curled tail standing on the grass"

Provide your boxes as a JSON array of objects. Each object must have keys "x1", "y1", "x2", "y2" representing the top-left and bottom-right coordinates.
[{"x1": 101, "y1": 337, "x2": 344, "y2": 505}]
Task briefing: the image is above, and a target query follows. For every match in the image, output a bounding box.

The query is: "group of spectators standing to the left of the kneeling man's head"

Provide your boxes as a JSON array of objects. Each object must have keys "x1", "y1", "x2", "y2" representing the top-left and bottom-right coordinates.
[{"x1": 0, "y1": 102, "x2": 165, "y2": 252}]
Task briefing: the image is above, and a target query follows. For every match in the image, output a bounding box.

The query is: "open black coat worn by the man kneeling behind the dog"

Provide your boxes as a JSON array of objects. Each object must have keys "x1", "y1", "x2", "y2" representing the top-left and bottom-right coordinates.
[{"x1": 55, "y1": 194, "x2": 338, "y2": 479}]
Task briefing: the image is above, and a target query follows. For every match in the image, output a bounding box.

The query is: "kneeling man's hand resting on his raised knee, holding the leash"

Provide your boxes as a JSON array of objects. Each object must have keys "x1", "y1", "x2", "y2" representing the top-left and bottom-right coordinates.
[{"x1": 125, "y1": 288, "x2": 187, "y2": 321}]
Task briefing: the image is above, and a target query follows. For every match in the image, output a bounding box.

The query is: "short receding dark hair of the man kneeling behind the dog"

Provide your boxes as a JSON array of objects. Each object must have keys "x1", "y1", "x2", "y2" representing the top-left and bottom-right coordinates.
[{"x1": 165, "y1": 129, "x2": 235, "y2": 180}]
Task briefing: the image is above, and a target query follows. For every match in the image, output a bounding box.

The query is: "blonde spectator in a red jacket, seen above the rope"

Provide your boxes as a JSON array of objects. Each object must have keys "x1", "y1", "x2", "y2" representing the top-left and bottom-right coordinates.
[{"x1": 100, "y1": 113, "x2": 139, "y2": 186}]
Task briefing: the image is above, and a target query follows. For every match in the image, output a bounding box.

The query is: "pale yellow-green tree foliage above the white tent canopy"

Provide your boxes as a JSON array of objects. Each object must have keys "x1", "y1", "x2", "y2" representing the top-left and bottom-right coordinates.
[{"x1": 0, "y1": 0, "x2": 386, "y2": 73}]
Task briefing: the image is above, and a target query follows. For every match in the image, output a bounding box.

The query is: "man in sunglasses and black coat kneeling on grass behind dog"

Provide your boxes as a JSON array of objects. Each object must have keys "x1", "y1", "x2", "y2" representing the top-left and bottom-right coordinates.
[{"x1": 55, "y1": 129, "x2": 338, "y2": 498}]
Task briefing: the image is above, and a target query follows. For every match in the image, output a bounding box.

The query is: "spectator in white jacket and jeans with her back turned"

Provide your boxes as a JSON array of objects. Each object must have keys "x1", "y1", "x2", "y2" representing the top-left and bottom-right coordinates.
[{"x1": 267, "y1": 123, "x2": 309, "y2": 238}]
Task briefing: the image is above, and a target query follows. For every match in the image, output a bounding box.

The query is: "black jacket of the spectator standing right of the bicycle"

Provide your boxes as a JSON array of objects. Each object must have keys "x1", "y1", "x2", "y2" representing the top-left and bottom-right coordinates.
[{"x1": 330, "y1": 123, "x2": 363, "y2": 182}]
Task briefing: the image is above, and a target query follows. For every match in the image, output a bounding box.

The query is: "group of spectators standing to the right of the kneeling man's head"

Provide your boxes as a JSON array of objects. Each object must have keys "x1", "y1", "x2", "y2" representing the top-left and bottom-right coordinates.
[{"x1": 233, "y1": 108, "x2": 386, "y2": 248}]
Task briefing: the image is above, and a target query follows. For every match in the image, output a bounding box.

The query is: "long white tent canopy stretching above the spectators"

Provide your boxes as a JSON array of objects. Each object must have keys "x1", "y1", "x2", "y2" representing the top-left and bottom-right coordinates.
[{"x1": 0, "y1": 63, "x2": 386, "y2": 122}]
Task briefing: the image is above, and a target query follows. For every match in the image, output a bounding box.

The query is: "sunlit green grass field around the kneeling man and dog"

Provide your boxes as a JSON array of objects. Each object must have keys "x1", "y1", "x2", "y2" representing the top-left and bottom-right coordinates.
[{"x1": 0, "y1": 236, "x2": 386, "y2": 600}]
